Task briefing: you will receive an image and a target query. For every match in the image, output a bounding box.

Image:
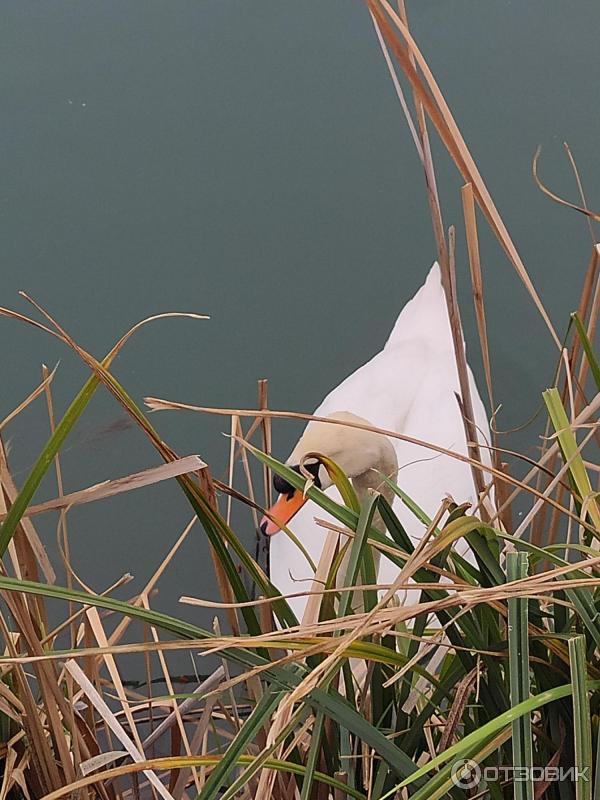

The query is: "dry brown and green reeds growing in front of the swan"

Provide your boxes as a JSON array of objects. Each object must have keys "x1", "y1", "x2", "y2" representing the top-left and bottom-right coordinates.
[{"x1": 0, "y1": 0, "x2": 600, "y2": 800}]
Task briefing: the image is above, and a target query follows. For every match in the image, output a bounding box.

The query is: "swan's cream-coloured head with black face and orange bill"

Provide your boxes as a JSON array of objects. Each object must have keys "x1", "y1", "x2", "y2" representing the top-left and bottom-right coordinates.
[{"x1": 260, "y1": 411, "x2": 398, "y2": 536}]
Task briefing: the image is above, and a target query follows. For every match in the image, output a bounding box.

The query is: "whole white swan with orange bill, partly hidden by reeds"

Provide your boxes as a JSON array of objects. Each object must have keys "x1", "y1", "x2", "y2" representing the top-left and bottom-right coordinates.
[{"x1": 261, "y1": 263, "x2": 489, "y2": 619}]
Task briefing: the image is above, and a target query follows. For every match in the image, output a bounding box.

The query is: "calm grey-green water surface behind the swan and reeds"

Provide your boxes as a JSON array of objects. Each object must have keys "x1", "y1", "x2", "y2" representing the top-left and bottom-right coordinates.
[{"x1": 0, "y1": 0, "x2": 600, "y2": 636}]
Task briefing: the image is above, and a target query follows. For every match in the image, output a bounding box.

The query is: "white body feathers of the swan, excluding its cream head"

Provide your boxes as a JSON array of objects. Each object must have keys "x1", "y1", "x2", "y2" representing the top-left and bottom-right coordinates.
[{"x1": 271, "y1": 263, "x2": 489, "y2": 618}]
